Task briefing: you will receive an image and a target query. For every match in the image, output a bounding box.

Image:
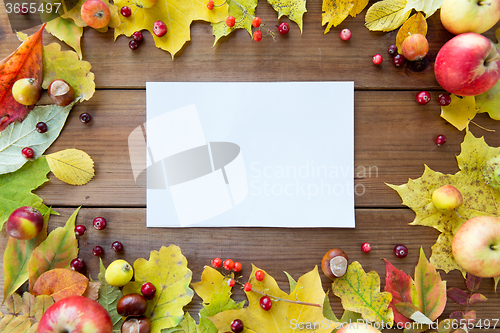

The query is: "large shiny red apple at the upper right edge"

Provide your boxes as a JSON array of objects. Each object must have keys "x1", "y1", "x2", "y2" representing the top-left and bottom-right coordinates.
[{"x1": 434, "y1": 32, "x2": 500, "y2": 96}]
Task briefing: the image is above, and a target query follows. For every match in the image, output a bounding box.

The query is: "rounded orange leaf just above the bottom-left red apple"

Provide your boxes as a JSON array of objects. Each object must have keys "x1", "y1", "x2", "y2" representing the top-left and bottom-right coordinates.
[{"x1": 33, "y1": 268, "x2": 89, "y2": 302}]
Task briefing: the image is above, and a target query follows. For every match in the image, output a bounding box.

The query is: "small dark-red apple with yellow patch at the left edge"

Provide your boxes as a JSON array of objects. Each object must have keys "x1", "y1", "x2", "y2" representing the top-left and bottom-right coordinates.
[{"x1": 6, "y1": 206, "x2": 43, "y2": 240}]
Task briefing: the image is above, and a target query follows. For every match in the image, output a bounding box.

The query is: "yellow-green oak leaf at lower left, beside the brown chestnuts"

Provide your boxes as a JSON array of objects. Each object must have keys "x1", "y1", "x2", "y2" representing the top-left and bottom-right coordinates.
[{"x1": 123, "y1": 245, "x2": 194, "y2": 333}]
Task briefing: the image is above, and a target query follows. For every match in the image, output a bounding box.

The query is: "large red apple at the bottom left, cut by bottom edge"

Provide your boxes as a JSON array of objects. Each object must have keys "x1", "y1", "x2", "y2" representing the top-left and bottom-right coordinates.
[{"x1": 37, "y1": 296, "x2": 113, "y2": 333}]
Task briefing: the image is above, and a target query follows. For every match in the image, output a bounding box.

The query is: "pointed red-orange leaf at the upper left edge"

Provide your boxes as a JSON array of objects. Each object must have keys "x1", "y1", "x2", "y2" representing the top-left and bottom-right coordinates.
[{"x1": 0, "y1": 24, "x2": 45, "y2": 132}]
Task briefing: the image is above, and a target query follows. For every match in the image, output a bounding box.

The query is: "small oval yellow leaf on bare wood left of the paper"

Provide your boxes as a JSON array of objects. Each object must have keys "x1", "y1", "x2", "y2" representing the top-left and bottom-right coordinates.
[{"x1": 46, "y1": 149, "x2": 94, "y2": 185}]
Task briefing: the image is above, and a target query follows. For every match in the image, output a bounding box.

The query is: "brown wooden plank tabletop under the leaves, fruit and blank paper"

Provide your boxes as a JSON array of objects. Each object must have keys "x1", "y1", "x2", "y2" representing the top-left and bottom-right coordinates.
[{"x1": 0, "y1": 0, "x2": 500, "y2": 330}]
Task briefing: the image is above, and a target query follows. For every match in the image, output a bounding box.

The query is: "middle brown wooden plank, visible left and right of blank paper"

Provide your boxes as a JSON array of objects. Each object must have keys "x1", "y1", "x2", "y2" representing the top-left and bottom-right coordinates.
[{"x1": 37, "y1": 90, "x2": 500, "y2": 207}]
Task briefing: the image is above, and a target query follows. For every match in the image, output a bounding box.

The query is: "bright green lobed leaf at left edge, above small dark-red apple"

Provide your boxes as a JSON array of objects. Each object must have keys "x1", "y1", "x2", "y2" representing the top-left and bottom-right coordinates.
[{"x1": 0, "y1": 157, "x2": 57, "y2": 230}]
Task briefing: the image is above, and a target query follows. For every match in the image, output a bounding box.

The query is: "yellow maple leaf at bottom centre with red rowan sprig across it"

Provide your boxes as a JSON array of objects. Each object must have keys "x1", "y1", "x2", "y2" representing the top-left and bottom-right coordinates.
[{"x1": 209, "y1": 265, "x2": 332, "y2": 333}]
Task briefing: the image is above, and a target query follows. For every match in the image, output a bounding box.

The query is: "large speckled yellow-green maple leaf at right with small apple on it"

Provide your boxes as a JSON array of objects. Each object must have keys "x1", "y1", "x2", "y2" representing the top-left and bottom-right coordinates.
[{"x1": 388, "y1": 132, "x2": 500, "y2": 274}]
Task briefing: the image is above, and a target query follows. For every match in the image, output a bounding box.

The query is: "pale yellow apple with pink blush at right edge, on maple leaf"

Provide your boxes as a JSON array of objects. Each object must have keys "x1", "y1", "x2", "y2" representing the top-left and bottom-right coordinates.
[{"x1": 452, "y1": 216, "x2": 500, "y2": 278}]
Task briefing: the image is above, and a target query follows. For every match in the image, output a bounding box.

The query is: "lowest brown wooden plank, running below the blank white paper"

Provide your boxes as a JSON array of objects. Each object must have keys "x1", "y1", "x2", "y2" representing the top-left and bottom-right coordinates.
[{"x1": 0, "y1": 208, "x2": 500, "y2": 319}]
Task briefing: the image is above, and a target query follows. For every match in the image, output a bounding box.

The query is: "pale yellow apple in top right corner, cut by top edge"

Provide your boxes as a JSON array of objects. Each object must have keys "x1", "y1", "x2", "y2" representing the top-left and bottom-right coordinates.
[{"x1": 441, "y1": 0, "x2": 500, "y2": 35}]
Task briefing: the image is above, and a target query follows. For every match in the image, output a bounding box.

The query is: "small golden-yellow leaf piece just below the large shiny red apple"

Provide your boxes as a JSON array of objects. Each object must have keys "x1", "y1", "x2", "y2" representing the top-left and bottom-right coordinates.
[{"x1": 441, "y1": 95, "x2": 477, "y2": 131}]
